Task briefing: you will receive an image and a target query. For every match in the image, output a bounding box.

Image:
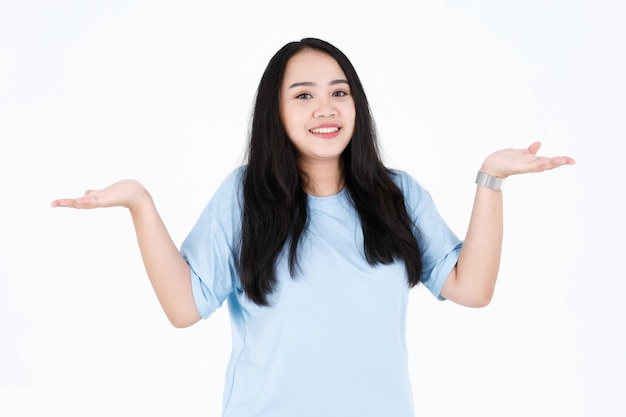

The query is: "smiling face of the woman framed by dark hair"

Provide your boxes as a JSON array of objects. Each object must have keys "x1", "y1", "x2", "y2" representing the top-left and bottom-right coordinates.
[{"x1": 280, "y1": 49, "x2": 356, "y2": 169}]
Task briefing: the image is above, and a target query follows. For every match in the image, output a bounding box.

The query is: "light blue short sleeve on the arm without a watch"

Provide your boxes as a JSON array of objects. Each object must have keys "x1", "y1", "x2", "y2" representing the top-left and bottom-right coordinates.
[{"x1": 180, "y1": 169, "x2": 241, "y2": 318}]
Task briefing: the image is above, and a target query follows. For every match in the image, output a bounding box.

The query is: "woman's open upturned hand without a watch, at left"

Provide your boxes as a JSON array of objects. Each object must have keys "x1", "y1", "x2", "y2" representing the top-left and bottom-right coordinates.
[{"x1": 51, "y1": 180, "x2": 148, "y2": 211}]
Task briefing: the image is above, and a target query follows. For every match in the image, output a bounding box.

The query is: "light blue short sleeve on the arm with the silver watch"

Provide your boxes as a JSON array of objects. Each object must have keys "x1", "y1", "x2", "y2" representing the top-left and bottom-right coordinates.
[{"x1": 392, "y1": 170, "x2": 463, "y2": 300}]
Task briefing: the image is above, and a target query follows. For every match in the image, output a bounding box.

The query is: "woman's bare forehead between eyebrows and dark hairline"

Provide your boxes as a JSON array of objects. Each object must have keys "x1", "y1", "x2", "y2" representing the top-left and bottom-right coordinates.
[{"x1": 283, "y1": 49, "x2": 346, "y2": 85}]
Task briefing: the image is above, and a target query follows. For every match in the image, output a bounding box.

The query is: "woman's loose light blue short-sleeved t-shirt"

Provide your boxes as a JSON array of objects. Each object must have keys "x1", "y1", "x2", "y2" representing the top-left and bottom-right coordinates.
[{"x1": 181, "y1": 167, "x2": 462, "y2": 417}]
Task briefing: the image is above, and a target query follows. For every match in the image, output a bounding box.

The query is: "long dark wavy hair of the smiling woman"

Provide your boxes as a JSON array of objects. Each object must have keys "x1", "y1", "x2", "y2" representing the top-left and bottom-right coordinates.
[{"x1": 239, "y1": 38, "x2": 422, "y2": 305}]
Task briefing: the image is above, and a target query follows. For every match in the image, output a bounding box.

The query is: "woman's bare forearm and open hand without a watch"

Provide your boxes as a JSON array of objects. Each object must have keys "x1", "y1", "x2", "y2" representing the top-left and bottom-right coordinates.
[{"x1": 52, "y1": 180, "x2": 200, "y2": 327}]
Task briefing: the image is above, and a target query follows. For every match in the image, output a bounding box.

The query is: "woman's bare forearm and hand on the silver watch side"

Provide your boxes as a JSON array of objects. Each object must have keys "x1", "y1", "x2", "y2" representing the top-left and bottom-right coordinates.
[{"x1": 441, "y1": 142, "x2": 574, "y2": 307}]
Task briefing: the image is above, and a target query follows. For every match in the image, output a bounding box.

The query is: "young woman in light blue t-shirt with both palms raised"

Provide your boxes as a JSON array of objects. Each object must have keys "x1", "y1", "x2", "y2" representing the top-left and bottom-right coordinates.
[{"x1": 52, "y1": 39, "x2": 574, "y2": 417}]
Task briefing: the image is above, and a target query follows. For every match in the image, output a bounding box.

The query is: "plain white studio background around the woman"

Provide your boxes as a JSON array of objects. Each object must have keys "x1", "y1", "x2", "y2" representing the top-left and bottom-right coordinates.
[{"x1": 0, "y1": 0, "x2": 626, "y2": 417}]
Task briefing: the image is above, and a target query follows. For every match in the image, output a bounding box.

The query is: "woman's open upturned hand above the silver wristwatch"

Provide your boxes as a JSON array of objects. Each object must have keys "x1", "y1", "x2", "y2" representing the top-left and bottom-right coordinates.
[{"x1": 480, "y1": 142, "x2": 576, "y2": 178}]
